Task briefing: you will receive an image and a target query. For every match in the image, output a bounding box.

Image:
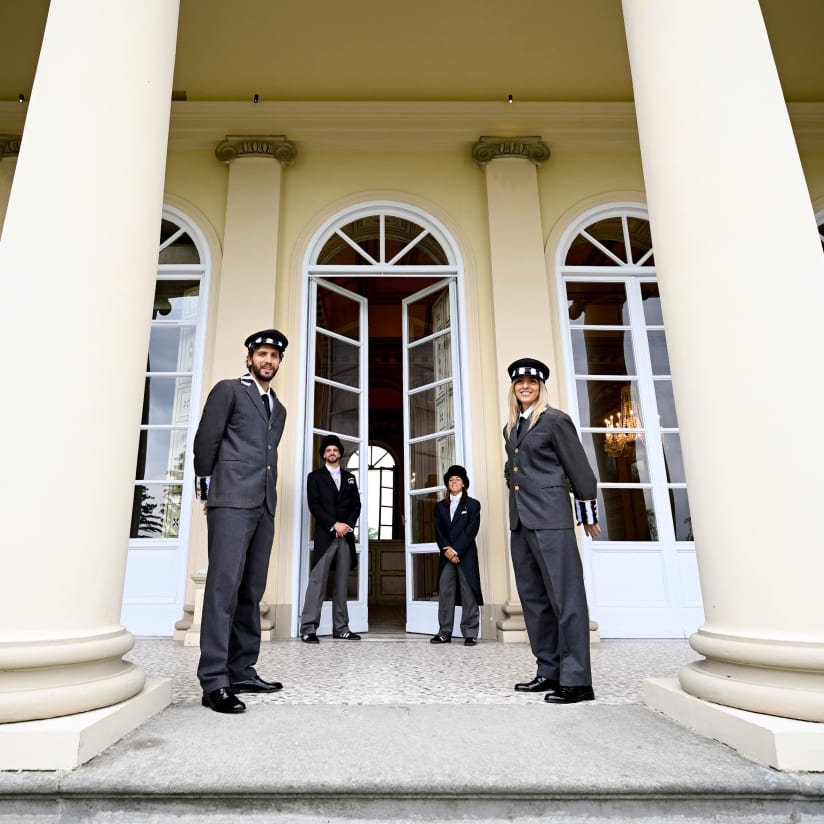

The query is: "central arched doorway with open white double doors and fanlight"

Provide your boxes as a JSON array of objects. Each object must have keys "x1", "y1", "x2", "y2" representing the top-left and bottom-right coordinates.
[{"x1": 298, "y1": 203, "x2": 469, "y2": 634}]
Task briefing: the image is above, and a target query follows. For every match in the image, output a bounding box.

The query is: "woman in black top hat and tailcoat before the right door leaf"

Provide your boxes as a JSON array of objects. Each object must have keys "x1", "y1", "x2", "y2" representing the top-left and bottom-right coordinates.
[{"x1": 429, "y1": 464, "x2": 484, "y2": 647}]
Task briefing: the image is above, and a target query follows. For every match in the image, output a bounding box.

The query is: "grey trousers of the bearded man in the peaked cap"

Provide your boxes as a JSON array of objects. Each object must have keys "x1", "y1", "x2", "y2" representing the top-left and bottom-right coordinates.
[{"x1": 197, "y1": 504, "x2": 275, "y2": 692}]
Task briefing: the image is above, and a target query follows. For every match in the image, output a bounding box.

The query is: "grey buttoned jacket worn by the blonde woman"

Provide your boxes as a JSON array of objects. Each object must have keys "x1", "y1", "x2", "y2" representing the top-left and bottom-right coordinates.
[{"x1": 504, "y1": 406, "x2": 598, "y2": 529}]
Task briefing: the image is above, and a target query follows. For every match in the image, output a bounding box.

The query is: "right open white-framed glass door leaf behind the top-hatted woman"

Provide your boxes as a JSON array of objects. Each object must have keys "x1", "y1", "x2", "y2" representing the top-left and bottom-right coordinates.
[{"x1": 403, "y1": 278, "x2": 463, "y2": 633}]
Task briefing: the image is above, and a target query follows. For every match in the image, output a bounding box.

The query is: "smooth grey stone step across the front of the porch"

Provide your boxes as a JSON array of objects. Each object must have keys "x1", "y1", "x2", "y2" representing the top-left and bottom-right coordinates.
[{"x1": 0, "y1": 696, "x2": 824, "y2": 824}]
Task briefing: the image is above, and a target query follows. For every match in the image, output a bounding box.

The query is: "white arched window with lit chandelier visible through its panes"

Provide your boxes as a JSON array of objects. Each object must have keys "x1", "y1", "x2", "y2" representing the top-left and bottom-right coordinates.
[{"x1": 558, "y1": 205, "x2": 700, "y2": 635}]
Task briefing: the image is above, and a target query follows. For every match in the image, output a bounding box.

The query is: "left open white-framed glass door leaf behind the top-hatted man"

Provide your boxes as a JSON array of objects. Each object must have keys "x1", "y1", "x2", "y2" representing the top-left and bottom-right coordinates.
[{"x1": 300, "y1": 278, "x2": 369, "y2": 634}]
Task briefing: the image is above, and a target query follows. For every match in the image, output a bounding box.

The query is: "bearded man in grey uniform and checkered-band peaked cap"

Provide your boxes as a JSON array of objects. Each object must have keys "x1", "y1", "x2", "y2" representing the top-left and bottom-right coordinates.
[{"x1": 194, "y1": 329, "x2": 289, "y2": 713}]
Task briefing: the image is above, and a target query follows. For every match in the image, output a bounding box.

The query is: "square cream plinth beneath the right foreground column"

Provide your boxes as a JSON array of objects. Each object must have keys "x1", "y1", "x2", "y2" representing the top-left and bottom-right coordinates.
[{"x1": 644, "y1": 678, "x2": 824, "y2": 772}]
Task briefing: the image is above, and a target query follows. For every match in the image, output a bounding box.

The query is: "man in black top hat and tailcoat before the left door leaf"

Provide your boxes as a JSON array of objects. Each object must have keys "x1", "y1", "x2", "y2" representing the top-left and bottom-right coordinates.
[{"x1": 300, "y1": 435, "x2": 361, "y2": 644}]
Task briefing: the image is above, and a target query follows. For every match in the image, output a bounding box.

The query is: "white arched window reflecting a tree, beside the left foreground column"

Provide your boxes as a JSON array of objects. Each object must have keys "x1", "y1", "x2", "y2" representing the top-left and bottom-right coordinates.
[{"x1": 123, "y1": 207, "x2": 209, "y2": 635}]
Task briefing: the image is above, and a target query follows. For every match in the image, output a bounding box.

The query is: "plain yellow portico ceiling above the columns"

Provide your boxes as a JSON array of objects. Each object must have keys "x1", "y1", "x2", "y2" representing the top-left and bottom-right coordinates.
[{"x1": 0, "y1": 0, "x2": 824, "y2": 103}]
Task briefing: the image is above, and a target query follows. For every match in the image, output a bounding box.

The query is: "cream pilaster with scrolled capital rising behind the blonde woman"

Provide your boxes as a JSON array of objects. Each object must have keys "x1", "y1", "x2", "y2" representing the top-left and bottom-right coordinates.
[{"x1": 472, "y1": 137, "x2": 553, "y2": 641}]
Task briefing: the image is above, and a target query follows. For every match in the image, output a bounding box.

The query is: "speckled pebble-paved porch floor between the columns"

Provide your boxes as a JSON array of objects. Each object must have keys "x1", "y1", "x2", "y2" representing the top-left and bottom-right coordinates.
[{"x1": 126, "y1": 635, "x2": 700, "y2": 704}]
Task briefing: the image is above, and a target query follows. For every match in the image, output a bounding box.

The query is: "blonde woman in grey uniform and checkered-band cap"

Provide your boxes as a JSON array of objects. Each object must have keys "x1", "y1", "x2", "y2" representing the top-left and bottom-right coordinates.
[{"x1": 503, "y1": 358, "x2": 601, "y2": 704}]
